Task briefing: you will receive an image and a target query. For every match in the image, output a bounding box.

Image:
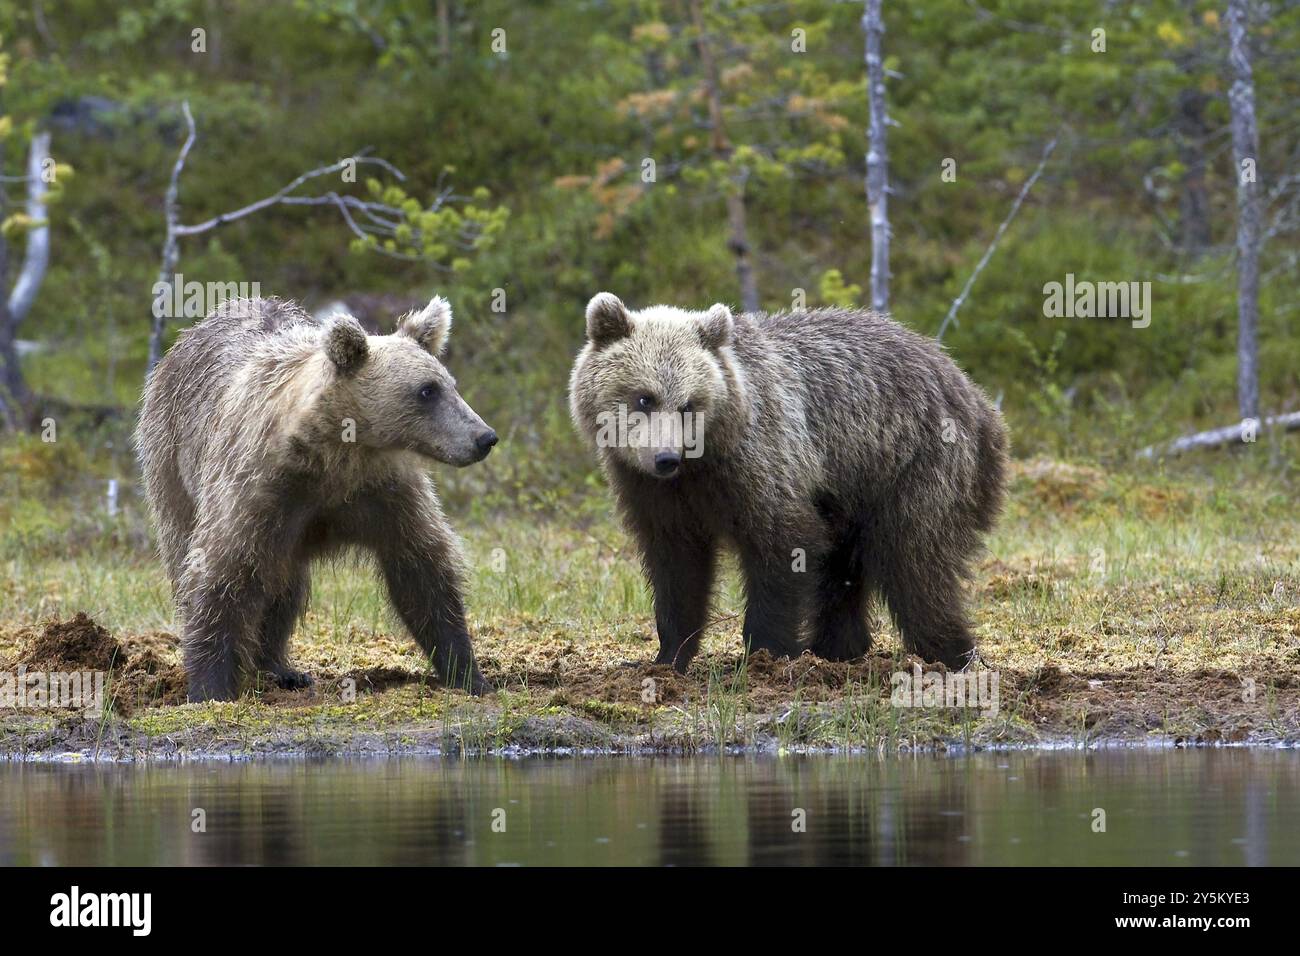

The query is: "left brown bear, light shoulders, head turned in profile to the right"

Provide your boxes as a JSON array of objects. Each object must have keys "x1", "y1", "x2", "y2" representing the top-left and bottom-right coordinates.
[{"x1": 137, "y1": 298, "x2": 497, "y2": 701}]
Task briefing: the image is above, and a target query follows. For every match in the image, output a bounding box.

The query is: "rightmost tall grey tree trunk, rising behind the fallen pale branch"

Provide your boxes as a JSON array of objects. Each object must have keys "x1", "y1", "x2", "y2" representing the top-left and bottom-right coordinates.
[{"x1": 1227, "y1": 0, "x2": 1260, "y2": 419}]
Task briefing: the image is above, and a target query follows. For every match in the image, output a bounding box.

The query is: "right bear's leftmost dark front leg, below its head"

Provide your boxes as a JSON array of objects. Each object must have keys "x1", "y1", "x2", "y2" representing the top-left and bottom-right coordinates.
[{"x1": 644, "y1": 537, "x2": 718, "y2": 674}]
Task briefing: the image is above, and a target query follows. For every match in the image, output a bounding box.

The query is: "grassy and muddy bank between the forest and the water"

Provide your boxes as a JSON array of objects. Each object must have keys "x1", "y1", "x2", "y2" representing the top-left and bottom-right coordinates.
[{"x1": 0, "y1": 460, "x2": 1300, "y2": 754}]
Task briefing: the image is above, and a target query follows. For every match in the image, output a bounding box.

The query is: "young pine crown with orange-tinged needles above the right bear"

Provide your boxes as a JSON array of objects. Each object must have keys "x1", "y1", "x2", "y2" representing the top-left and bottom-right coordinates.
[{"x1": 566, "y1": 3, "x2": 861, "y2": 247}]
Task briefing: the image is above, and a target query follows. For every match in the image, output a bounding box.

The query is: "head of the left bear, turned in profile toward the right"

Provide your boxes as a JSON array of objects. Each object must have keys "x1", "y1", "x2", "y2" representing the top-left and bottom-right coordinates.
[{"x1": 322, "y1": 297, "x2": 497, "y2": 466}]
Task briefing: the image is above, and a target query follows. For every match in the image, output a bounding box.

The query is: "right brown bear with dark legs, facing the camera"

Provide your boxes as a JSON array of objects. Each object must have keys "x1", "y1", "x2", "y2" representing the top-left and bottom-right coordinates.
[{"x1": 569, "y1": 293, "x2": 1006, "y2": 670}]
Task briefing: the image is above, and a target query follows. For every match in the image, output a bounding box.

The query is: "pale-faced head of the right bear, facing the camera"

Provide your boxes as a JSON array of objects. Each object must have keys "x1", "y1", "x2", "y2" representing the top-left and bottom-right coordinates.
[{"x1": 569, "y1": 293, "x2": 746, "y2": 480}]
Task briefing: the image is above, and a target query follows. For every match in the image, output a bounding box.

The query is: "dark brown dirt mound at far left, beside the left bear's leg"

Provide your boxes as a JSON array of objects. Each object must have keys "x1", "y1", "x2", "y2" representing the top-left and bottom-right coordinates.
[{"x1": 8, "y1": 611, "x2": 186, "y2": 715}]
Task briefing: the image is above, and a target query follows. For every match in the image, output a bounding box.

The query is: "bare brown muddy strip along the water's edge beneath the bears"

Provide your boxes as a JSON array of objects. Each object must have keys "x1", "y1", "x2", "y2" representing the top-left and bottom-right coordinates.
[{"x1": 0, "y1": 614, "x2": 1300, "y2": 760}]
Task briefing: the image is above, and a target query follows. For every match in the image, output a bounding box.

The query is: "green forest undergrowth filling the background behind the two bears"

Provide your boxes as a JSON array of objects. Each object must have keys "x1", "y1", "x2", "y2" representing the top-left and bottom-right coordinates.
[{"x1": 0, "y1": 0, "x2": 1300, "y2": 510}]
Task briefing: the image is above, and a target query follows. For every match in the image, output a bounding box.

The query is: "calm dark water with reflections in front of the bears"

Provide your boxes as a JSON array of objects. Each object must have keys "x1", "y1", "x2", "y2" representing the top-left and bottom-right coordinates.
[{"x1": 0, "y1": 749, "x2": 1300, "y2": 865}]
